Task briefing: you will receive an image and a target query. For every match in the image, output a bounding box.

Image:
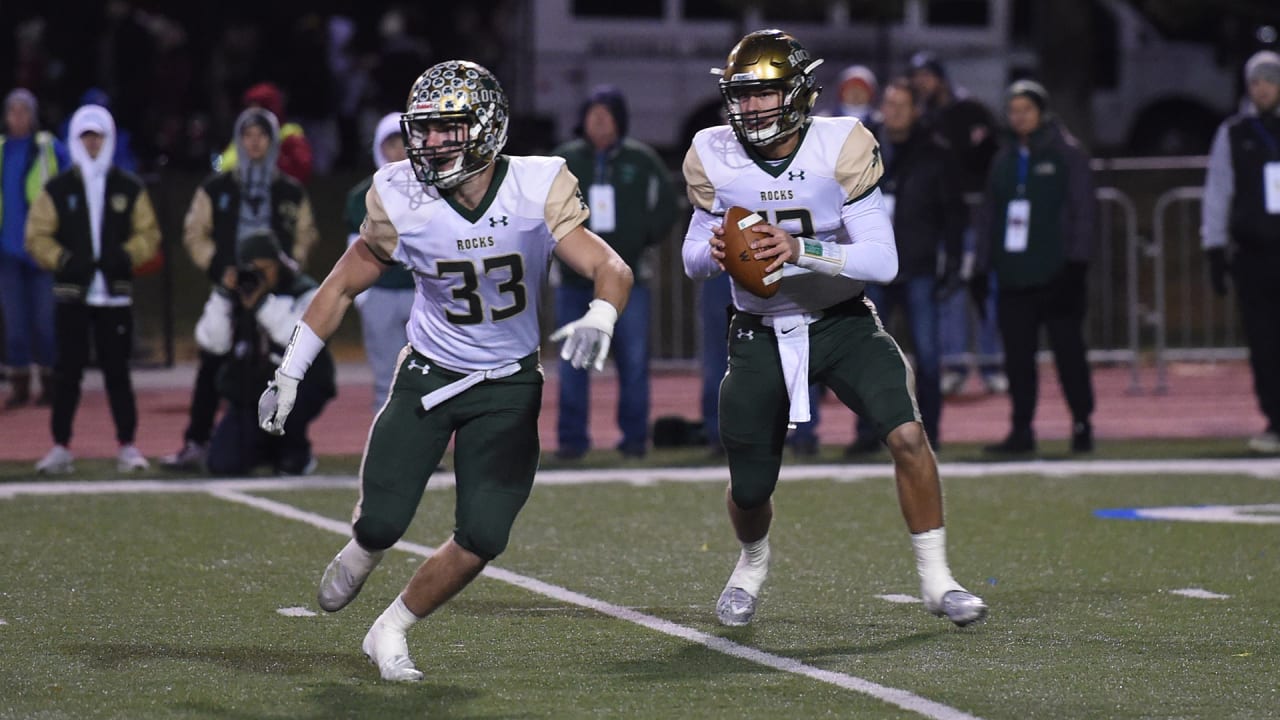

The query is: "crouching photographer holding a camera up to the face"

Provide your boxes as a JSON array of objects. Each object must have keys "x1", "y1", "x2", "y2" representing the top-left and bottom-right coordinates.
[{"x1": 196, "y1": 231, "x2": 337, "y2": 475}]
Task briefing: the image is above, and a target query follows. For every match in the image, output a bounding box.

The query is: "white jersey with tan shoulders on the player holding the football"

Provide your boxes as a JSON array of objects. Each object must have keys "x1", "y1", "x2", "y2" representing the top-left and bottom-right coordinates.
[{"x1": 684, "y1": 118, "x2": 884, "y2": 315}]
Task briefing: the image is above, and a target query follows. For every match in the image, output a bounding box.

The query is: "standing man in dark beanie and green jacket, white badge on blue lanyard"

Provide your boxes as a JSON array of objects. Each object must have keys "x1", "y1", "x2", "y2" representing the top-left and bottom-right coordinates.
[{"x1": 977, "y1": 79, "x2": 1096, "y2": 454}]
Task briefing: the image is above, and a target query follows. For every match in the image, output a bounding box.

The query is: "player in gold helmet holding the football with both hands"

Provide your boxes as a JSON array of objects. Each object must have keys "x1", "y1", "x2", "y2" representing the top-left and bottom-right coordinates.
[{"x1": 682, "y1": 29, "x2": 987, "y2": 625}]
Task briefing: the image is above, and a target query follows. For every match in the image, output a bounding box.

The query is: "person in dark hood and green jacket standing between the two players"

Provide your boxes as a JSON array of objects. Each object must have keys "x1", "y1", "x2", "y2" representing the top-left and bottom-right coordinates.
[{"x1": 554, "y1": 86, "x2": 676, "y2": 460}]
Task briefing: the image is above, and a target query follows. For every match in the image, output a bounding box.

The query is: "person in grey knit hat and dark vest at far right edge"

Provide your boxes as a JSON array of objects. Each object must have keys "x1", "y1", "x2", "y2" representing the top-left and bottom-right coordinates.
[{"x1": 1201, "y1": 50, "x2": 1280, "y2": 454}]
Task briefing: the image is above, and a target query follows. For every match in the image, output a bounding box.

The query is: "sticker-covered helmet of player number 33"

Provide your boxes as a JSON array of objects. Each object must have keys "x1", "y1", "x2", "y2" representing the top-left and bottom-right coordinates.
[{"x1": 401, "y1": 60, "x2": 511, "y2": 190}]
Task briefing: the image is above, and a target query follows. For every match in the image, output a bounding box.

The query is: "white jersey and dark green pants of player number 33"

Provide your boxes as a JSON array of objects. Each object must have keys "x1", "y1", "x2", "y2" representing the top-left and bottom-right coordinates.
[{"x1": 355, "y1": 151, "x2": 588, "y2": 559}]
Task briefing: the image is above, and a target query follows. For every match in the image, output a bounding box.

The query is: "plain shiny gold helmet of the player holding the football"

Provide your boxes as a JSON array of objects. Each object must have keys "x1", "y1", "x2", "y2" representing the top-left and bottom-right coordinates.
[{"x1": 712, "y1": 29, "x2": 822, "y2": 145}]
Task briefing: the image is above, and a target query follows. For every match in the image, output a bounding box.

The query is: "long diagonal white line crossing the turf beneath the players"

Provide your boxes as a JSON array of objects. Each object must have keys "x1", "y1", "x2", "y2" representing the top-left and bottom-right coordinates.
[{"x1": 209, "y1": 489, "x2": 979, "y2": 720}]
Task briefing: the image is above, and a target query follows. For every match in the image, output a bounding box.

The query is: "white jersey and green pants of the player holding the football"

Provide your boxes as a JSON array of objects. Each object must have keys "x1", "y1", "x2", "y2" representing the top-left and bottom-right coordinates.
[{"x1": 682, "y1": 118, "x2": 919, "y2": 509}]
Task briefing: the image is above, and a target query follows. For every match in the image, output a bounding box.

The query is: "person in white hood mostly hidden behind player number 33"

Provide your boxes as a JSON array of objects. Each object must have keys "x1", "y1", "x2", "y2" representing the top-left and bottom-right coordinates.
[{"x1": 346, "y1": 113, "x2": 413, "y2": 413}]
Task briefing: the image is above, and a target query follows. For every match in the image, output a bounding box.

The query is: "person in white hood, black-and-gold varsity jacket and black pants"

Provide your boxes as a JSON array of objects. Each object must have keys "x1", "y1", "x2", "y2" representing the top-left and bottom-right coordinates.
[{"x1": 26, "y1": 105, "x2": 160, "y2": 473}]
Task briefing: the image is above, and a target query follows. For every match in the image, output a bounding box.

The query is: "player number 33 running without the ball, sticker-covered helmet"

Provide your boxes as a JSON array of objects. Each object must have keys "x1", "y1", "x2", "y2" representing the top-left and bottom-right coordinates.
[{"x1": 259, "y1": 61, "x2": 632, "y2": 682}]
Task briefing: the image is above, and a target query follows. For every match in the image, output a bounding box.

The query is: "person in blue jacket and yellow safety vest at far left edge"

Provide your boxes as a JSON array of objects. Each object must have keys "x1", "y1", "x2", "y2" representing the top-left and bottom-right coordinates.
[{"x1": 0, "y1": 88, "x2": 70, "y2": 410}]
